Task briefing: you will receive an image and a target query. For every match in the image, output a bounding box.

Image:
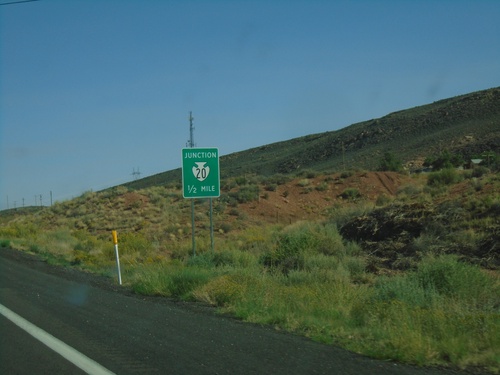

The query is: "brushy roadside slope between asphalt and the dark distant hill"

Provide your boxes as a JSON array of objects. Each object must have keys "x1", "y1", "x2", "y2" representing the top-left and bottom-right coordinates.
[{"x1": 0, "y1": 164, "x2": 500, "y2": 373}]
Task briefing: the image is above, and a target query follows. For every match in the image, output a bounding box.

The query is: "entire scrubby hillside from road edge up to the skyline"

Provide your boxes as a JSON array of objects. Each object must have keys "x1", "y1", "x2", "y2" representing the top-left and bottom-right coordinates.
[{"x1": 0, "y1": 87, "x2": 500, "y2": 374}]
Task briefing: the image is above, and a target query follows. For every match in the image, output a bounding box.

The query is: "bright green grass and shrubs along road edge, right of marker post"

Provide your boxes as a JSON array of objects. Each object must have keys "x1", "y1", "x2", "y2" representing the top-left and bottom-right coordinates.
[{"x1": 115, "y1": 223, "x2": 500, "y2": 373}]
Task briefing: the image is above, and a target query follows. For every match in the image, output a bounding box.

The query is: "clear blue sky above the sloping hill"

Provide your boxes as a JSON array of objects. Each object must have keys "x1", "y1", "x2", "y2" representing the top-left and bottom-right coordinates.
[{"x1": 0, "y1": 0, "x2": 500, "y2": 209}]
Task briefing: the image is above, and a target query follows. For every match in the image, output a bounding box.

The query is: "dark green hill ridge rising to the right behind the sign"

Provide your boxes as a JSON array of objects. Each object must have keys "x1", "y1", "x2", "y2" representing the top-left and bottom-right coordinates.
[{"x1": 125, "y1": 87, "x2": 500, "y2": 189}]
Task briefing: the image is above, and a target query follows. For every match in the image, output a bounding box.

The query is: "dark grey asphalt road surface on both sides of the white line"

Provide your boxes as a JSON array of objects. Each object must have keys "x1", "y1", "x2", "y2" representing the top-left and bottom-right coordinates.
[{"x1": 0, "y1": 249, "x2": 470, "y2": 375}]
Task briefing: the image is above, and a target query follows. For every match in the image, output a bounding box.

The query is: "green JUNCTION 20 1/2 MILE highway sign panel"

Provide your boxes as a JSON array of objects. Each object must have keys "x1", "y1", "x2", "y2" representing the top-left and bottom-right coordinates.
[{"x1": 182, "y1": 148, "x2": 220, "y2": 198}]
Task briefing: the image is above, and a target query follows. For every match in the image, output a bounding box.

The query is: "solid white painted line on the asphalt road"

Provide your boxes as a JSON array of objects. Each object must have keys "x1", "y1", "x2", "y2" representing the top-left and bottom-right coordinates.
[{"x1": 0, "y1": 304, "x2": 115, "y2": 375}]
